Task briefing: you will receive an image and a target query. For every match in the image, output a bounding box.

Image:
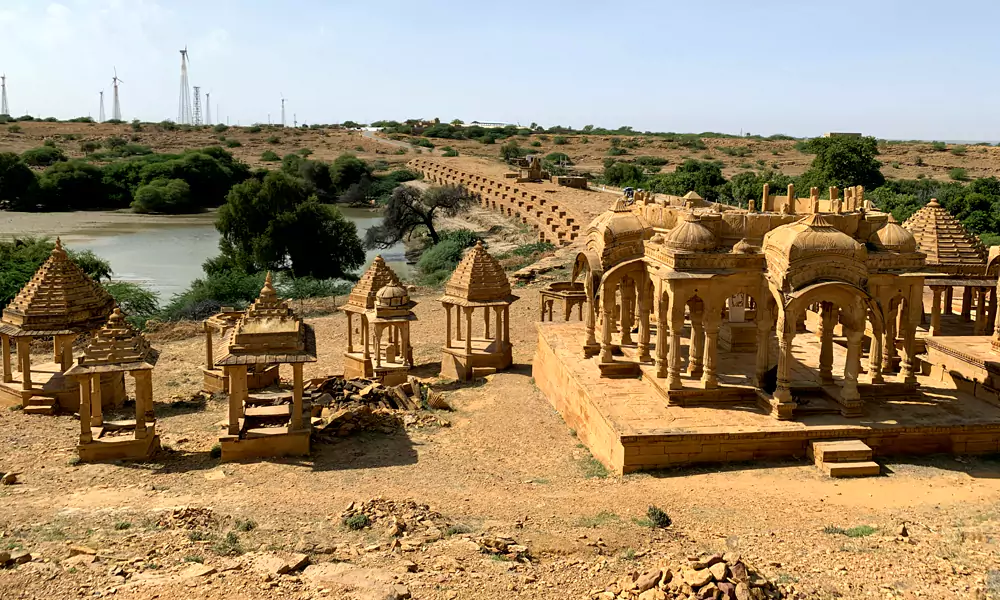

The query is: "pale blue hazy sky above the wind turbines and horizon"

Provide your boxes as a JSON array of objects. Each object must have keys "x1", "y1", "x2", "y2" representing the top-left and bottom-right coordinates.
[{"x1": 0, "y1": 0, "x2": 1000, "y2": 140}]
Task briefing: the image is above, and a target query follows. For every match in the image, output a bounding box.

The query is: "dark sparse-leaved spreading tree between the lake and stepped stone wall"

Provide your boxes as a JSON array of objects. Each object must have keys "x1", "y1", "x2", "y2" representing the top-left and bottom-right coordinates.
[{"x1": 365, "y1": 185, "x2": 472, "y2": 248}]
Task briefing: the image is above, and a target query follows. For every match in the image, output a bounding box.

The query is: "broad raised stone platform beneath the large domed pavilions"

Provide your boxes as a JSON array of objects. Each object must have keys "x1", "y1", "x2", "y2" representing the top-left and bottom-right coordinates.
[{"x1": 532, "y1": 323, "x2": 1000, "y2": 473}]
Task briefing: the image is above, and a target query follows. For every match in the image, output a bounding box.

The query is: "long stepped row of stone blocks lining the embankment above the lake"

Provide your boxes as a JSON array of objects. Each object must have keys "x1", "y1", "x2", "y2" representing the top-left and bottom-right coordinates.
[{"x1": 407, "y1": 158, "x2": 580, "y2": 245}]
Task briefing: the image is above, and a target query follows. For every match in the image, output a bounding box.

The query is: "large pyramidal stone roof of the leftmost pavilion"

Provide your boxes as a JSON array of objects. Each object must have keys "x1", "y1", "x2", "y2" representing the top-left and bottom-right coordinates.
[{"x1": 2, "y1": 238, "x2": 115, "y2": 335}]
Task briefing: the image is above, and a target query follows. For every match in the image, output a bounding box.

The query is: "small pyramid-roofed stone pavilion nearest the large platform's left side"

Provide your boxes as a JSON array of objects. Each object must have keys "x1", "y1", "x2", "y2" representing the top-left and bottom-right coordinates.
[{"x1": 441, "y1": 242, "x2": 517, "y2": 381}]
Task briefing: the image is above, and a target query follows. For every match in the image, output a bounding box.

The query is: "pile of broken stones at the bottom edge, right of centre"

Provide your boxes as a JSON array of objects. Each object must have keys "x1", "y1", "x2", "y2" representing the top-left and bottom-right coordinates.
[{"x1": 590, "y1": 552, "x2": 806, "y2": 600}]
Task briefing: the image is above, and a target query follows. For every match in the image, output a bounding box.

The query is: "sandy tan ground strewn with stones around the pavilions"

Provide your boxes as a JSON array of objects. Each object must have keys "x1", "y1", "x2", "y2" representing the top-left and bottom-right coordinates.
[{"x1": 0, "y1": 282, "x2": 1000, "y2": 599}]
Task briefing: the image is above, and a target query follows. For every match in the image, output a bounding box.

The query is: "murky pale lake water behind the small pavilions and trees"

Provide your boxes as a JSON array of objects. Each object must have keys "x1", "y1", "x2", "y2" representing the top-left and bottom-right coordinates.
[{"x1": 62, "y1": 208, "x2": 410, "y2": 301}]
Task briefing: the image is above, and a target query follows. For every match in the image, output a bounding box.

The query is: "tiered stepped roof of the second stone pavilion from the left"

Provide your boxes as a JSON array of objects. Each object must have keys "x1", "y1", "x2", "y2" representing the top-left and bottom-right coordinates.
[{"x1": 67, "y1": 307, "x2": 158, "y2": 375}]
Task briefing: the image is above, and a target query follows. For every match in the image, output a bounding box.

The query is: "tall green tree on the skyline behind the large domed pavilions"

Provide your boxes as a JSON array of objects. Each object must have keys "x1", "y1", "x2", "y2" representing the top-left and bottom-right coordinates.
[{"x1": 799, "y1": 137, "x2": 885, "y2": 190}]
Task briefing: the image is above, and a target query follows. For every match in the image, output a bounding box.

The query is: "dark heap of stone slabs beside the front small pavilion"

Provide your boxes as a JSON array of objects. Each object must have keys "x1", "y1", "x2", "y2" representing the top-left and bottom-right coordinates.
[{"x1": 312, "y1": 376, "x2": 450, "y2": 437}]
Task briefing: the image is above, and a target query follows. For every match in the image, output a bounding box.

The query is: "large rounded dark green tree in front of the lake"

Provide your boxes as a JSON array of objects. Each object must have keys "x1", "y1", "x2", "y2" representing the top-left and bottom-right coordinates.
[{"x1": 215, "y1": 171, "x2": 365, "y2": 279}]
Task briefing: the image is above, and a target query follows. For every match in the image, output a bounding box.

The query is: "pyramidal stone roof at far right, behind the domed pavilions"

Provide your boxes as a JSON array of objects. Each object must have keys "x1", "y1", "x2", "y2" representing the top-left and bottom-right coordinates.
[{"x1": 903, "y1": 198, "x2": 986, "y2": 269}]
